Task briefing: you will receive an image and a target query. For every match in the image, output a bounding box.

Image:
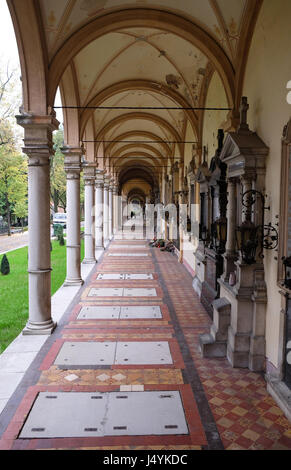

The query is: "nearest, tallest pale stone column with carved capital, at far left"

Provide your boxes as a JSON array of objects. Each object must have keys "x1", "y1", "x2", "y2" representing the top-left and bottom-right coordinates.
[{"x1": 16, "y1": 114, "x2": 59, "y2": 335}]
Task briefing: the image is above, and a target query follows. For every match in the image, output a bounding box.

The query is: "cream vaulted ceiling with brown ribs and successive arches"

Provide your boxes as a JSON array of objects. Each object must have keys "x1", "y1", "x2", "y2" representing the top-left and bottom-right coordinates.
[{"x1": 8, "y1": 0, "x2": 261, "y2": 191}]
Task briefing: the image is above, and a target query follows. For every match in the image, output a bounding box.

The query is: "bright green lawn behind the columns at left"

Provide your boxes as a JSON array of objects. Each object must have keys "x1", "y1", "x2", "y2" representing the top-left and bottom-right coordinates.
[{"x1": 0, "y1": 240, "x2": 84, "y2": 354}]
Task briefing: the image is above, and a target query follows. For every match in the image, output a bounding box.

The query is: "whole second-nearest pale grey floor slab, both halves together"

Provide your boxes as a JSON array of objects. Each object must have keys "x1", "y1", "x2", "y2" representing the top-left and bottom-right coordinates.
[{"x1": 54, "y1": 341, "x2": 173, "y2": 367}]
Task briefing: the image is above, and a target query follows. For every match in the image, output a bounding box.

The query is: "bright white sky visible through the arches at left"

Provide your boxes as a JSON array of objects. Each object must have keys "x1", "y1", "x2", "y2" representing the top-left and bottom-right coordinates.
[{"x1": 0, "y1": 0, "x2": 63, "y2": 122}]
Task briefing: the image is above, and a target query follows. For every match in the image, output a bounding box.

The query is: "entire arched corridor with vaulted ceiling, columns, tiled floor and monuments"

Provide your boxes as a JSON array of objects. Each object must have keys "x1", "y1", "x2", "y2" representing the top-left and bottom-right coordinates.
[{"x1": 0, "y1": 0, "x2": 291, "y2": 450}]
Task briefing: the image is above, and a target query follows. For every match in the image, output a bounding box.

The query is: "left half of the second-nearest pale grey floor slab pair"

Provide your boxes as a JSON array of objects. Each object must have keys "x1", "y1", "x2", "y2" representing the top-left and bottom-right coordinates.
[{"x1": 54, "y1": 341, "x2": 116, "y2": 366}]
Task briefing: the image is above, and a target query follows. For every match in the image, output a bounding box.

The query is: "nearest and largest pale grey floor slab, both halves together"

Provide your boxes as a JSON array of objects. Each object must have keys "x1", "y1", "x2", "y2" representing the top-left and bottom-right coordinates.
[{"x1": 19, "y1": 391, "x2": 189, "y2": 439}]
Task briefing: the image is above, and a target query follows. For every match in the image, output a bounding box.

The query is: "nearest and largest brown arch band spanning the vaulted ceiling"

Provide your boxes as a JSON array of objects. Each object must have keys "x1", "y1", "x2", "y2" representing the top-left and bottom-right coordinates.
[{"x1": 48, "y1": 8, "x2": 235, "y2": 107}]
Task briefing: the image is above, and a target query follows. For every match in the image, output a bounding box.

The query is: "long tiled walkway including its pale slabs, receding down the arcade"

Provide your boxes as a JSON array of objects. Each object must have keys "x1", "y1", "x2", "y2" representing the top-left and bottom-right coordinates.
[{"x1": 0, "y1": 231, "x2": 291, "y2": 450}]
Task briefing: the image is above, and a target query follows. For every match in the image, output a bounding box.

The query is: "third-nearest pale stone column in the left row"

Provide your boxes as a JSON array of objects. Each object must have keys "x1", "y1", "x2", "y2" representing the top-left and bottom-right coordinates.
[{"x1": 83, "y1": 163, "x2": 96, "y2": 264}]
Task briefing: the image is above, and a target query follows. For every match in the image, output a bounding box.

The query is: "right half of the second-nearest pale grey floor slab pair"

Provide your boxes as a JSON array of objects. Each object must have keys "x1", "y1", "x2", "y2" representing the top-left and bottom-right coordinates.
[{"x1": 115, "y1": 341, "x2": 173, "y2": 365}]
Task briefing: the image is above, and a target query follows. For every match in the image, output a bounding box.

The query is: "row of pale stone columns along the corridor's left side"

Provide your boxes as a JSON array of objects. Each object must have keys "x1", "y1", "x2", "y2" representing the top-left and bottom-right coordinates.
[{"x1": 17, "y1": 120, "x2": 119, "y2": 335}]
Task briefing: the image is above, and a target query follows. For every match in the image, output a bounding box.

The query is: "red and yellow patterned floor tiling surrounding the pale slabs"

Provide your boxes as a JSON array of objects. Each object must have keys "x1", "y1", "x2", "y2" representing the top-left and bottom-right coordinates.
[{"x1": 0, "y1": 233, "x2": 291, "y2": 450}]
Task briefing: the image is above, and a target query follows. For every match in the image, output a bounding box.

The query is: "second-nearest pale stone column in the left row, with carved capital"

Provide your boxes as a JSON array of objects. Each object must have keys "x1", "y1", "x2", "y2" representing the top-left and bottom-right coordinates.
[{"x1": 62, "y1": 147, "x2": 84, "y2": 286}]
